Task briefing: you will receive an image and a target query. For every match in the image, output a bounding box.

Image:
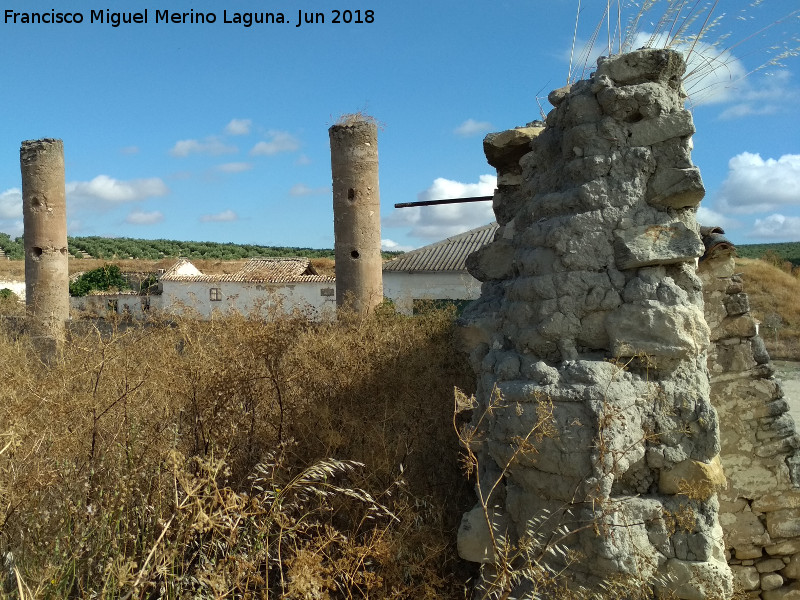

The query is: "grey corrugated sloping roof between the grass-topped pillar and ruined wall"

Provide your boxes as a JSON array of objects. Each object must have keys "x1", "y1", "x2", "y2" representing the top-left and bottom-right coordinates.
[{"x1": 383, "y1": 223, "x2": 498, "y2": 273}]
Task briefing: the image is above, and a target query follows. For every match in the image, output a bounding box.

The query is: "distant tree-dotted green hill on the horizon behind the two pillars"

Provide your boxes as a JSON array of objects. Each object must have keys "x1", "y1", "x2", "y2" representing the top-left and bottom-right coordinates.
[{"x1": 0, "y1": 233, "x2": 402, "y2": 260}]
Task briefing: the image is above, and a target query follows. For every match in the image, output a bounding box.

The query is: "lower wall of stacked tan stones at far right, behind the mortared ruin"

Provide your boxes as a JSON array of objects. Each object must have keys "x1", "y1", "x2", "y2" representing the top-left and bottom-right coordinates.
[{"x1": 699, "y1": 234, "x2": 800, "y2": 600}]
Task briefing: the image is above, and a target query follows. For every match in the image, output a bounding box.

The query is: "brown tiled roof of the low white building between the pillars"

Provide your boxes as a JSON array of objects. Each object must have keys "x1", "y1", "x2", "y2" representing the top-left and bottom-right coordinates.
[{"x1": 161, "y1": 258, "x2": 335, "y2": 283}]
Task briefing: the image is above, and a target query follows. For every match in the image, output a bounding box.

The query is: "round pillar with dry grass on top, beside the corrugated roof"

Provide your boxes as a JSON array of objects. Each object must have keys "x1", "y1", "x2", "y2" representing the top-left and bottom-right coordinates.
[{"x1": 328, "y1": 115, "x2": 383, "y2": 312}]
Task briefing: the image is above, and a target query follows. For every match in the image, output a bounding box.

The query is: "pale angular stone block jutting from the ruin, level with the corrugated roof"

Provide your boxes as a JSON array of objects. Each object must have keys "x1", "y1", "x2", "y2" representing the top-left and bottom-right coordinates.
[{"x1": 614, "y1": 221, "x2": 700, "y2": 268}]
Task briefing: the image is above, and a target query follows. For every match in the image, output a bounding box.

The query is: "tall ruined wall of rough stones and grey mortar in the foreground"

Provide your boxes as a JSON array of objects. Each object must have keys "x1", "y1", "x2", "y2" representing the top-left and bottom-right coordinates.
[{"x1": 459, "y1": 50, "x2": 731, "y2": 599}]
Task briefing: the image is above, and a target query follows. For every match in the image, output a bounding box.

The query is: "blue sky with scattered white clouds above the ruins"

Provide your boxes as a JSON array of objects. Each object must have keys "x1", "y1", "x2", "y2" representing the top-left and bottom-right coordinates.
[{"x1": 0, "y1": 0, "x2": 800, "y2": 249}]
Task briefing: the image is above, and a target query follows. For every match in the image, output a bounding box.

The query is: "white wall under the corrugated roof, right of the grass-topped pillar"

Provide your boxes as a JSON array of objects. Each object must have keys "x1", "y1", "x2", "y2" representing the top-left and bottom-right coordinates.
[{"x1": 383, "y1": 271, "x2": 481, "y2": 314}]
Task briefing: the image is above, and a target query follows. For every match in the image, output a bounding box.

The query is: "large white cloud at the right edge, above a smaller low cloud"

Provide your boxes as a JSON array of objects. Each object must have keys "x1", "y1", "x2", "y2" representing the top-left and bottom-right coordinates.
[{"x1": 718, "y1": 152, "x2": 800, "y2": 214}]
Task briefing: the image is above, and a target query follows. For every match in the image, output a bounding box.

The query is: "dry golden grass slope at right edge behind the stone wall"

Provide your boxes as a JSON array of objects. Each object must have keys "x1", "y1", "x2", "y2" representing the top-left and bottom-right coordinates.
[{"x1": 736, "y1": 258, "x2": 800, "y2": 360}]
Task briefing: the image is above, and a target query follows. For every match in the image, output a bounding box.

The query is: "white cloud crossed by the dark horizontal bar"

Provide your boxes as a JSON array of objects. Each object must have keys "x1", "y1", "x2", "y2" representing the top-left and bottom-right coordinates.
[{"x1": 384, "y1": 175, "x2": 497, "y2": 241}]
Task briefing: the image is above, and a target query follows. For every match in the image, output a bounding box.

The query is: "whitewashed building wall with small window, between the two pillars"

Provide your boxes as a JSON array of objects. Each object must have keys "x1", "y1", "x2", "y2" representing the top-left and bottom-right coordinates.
[{"x1": 161, "y1": 281, "x2": 336, "y2": 318}]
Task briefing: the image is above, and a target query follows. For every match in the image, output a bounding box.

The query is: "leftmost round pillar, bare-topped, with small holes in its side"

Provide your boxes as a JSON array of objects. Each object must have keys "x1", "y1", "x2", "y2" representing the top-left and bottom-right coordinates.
[{"x1": 19, "y1": 139, "x2": 69, "y2": 346}]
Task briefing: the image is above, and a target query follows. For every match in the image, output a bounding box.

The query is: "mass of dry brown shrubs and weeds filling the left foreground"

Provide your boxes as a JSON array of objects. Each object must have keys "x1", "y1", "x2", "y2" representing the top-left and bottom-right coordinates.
[{"x1": 0, "y1": 309, "x2": 472, "y2": 598}]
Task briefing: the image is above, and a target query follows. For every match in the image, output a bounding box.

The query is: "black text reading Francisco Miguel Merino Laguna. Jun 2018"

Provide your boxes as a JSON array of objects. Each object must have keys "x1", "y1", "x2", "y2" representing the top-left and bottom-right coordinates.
[{"x1": 4, "y1": 9, "x2": 375, "y2": 27}]
